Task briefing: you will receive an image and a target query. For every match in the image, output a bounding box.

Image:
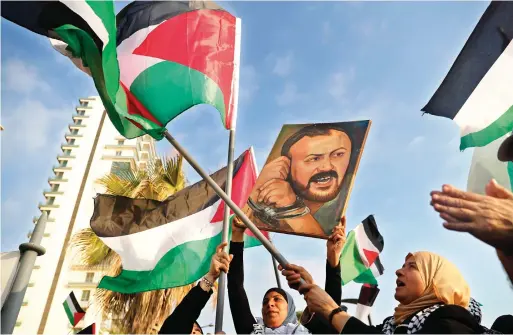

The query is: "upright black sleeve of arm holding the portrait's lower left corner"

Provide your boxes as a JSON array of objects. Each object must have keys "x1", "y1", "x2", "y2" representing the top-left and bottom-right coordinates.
[{"x1": 228, "y1": 242, "x2": 256, "y2": 334}]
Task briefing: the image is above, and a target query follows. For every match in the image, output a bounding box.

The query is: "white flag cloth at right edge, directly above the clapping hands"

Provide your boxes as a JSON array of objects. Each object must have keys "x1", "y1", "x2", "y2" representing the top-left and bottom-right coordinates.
[{"x1": 467, "y1": 135, "x2": 513, "y2": 194}]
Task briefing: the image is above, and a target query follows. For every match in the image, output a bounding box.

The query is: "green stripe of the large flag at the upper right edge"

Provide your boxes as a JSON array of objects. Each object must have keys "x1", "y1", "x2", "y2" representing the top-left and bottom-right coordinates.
[{"x1": 460, "y1": 106, "x2": 513, "y2": 150}]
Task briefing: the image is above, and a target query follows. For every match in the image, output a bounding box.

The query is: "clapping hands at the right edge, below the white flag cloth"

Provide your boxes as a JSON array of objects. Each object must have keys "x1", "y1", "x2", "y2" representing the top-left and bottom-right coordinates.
[{"x1": 431, "y1": 180, "x2": 513, "y2": 254}]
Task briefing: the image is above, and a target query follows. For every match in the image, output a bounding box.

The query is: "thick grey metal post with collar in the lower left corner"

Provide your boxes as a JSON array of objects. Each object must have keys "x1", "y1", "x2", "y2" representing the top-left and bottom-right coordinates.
[{"x1": 1, "y1": 211, "x2": 48, "y2": 334}]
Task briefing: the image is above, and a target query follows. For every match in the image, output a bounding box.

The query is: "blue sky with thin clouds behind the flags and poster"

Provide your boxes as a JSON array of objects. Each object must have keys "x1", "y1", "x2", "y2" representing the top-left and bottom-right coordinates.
[{"x1": 0, "y1": 2, "x2": 513, "y2": 332}]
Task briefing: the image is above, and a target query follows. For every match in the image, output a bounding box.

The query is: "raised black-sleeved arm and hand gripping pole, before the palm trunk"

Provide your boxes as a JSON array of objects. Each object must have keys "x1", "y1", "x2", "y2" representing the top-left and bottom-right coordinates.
[{"x1": 159, "y1": 243, "x2": 233, "y2": 334}]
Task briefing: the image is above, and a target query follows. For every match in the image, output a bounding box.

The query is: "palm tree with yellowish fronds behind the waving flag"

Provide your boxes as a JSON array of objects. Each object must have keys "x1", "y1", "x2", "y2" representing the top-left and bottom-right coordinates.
[{"x1": 70, "y1": 156, "x2": 216, "y2": 334}]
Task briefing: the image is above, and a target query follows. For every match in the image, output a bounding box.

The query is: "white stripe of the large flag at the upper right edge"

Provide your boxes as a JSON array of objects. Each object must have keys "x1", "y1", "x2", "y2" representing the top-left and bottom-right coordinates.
[{"x1": 454, "y1": 42, "x2": 513, "y2": 137}]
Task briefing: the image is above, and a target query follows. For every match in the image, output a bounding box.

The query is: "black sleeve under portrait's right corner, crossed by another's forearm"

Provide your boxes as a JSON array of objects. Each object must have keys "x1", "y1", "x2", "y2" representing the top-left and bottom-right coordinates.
[{"x1": 304, "y1": 261, "x2": 342, "y2": 334}]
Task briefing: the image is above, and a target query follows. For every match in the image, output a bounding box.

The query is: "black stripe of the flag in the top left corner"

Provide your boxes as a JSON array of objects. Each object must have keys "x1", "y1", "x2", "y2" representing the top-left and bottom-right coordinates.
[{"x1": 1, "y1": 1, "x2": 103, "y2": 54}]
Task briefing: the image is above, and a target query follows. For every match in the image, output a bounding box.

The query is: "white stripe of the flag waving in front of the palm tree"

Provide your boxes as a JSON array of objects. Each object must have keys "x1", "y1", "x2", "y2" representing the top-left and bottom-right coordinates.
[{"x1": 101, "y1": 201, "x2": 223, "y2": 271}]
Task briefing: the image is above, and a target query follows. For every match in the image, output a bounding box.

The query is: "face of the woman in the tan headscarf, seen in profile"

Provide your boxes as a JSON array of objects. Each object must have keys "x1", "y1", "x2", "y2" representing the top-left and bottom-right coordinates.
[{"x1": 394, "y1": 256, "x2": 425, "y2": 305}]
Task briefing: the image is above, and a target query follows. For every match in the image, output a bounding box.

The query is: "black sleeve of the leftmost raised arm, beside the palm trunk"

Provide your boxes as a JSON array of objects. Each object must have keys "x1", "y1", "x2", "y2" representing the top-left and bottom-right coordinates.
[{"x1": 159, "y1": 285, "x2": 212, "y2": 334}]
